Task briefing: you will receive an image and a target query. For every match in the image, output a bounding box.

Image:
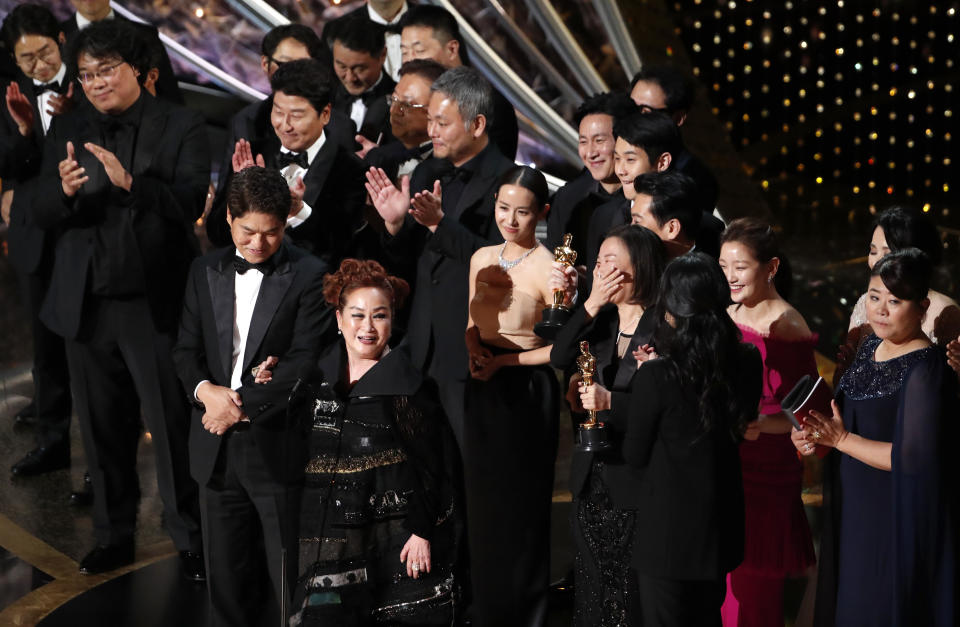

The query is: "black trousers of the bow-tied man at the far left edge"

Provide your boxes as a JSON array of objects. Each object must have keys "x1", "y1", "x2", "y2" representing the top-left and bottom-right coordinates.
[{"x1": 17, "y1": 267, "x2": 72, "y2": 446}]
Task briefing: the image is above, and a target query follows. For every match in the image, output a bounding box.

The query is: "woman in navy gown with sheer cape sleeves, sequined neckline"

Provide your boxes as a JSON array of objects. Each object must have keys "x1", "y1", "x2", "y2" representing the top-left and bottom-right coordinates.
[{"x1": 792, "y1": 249, "x2": 958, "y2": 627}]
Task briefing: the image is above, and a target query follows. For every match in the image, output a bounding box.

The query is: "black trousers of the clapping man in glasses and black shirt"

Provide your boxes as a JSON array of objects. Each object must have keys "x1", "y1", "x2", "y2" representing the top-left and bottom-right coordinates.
[{"x1": 67, "y1": 297, "x2": 202, "y2": 552}]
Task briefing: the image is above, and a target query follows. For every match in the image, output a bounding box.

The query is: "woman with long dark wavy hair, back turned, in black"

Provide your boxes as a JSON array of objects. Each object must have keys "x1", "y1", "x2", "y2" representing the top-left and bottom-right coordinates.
[{"x1": 612, "y1": 252, "x2": 761, "y2": 627}]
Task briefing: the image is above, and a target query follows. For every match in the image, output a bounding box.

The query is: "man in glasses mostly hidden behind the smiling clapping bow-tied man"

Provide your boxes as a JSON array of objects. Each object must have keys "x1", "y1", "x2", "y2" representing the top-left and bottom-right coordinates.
[{"x1": 214, "y1": 24, "x2": 357, "y2": 209}]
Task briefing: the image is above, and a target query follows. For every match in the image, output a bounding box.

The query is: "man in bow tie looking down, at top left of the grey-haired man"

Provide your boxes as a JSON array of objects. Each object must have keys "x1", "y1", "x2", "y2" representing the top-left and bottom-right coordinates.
[{"x1": 331, "y1": 18, "x2": 396, "y2": 145}]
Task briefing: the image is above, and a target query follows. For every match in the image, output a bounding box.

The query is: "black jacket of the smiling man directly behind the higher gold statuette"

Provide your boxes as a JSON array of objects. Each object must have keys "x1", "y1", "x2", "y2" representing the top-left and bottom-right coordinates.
[{"x1": 543, "y1": 168, "x2": 619, "y2": 255}]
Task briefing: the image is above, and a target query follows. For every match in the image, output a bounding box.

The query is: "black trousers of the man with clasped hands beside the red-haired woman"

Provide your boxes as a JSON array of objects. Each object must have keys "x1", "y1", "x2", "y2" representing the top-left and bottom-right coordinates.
[{"x1": 200, "y1": 425, "x2": 303, "y2": 627}]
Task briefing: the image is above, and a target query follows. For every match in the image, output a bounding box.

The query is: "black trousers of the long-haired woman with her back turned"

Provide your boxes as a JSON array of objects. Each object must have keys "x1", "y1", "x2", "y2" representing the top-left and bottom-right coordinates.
[{"x1": 631, "y1": 573, "x2": 727, "y2": 627}]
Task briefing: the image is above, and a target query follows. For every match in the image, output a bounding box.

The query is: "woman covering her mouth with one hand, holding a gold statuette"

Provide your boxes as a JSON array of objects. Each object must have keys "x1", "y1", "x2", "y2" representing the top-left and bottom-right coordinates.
[{"x1": 550, "y1": 225, "x2": 666, "y2": 627}]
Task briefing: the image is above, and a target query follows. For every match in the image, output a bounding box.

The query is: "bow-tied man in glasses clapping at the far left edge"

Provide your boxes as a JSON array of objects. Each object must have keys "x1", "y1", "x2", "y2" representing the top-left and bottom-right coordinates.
[{"x1": 0, "y1": 4, "x2": 73, "y2": 476}]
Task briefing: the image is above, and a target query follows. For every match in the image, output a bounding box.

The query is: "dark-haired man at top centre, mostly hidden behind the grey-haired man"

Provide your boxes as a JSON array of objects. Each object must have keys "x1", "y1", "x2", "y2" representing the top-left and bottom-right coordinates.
[{"x1": 399, "y1": 5, "x2": 520, "y2": 159}]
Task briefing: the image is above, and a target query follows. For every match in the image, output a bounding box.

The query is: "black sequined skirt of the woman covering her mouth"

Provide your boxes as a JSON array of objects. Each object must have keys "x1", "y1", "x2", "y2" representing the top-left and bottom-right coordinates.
[{"x1": 573, "y1": 460, "x2": 637, "y2": 627}]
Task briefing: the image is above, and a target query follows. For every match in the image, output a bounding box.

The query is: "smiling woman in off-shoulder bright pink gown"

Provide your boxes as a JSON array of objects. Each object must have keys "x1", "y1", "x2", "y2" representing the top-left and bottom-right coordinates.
[{"x1": 720, "y1": 218, "x2": 817, "y2": 627}]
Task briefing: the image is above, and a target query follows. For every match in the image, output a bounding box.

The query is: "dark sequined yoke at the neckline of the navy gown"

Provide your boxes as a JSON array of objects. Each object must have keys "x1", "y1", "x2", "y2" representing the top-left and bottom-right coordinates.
[{"x1": 840, "y1": 335, "x2": 938, "y2": 401}]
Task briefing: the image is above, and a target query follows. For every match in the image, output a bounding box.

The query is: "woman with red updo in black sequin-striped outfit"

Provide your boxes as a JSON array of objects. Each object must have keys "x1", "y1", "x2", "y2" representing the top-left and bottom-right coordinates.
[{"x1": 290, "y1": 259, "x2": 460, "y2": 625}]
